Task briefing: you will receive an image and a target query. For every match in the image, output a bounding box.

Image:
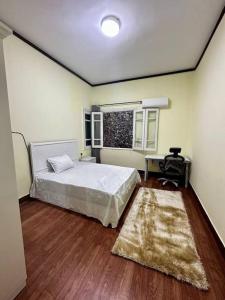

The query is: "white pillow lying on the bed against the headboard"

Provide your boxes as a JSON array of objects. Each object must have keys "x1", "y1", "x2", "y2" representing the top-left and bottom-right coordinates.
[{"x1": 48, "y1": 154, "x2": 74, "y2": 173}]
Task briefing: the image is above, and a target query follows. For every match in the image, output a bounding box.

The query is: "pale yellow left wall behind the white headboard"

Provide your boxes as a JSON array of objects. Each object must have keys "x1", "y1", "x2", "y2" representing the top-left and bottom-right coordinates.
[{"x1": 4, "y1": 36, "x2": 90, "y2": 197}]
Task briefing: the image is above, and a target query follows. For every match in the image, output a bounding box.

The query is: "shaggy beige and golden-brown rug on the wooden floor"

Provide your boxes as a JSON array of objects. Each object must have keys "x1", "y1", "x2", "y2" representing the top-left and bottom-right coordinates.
[{"x1": 112, "y1": 187, "x2": 208, "y2": 290}]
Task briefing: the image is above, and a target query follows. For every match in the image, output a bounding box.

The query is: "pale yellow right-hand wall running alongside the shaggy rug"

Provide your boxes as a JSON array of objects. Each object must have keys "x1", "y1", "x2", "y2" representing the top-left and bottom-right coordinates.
[{"x1": 191, "y1": 17, "x2": 225, "y2": 244}]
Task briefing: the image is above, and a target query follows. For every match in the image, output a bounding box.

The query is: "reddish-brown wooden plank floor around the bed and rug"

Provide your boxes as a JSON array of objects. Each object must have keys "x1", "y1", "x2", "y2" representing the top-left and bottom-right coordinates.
[{"x1": 16, "y1": 179, "x2": 225, "y2": 300}]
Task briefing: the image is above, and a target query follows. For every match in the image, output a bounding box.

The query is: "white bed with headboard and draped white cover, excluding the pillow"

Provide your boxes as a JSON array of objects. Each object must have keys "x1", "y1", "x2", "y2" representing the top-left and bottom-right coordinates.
[{"x1": 30, "y1": 140, "x2": 140, "y2": 228}]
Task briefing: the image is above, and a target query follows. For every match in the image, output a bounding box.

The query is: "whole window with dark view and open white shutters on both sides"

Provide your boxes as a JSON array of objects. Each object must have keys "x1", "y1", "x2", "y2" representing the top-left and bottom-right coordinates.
[{"x1": 88, "y1": 108, "x2": 159, "y2": 151}]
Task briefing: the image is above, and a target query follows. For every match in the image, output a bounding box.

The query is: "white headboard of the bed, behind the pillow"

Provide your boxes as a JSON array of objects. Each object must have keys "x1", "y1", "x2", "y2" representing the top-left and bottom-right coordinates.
[{"x1": 30, "y1": 140, "x2": 80, "y2": 178}]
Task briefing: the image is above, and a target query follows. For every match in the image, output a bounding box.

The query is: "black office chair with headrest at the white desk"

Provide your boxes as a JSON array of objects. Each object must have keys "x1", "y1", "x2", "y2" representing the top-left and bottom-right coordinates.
[{"x1": 158, "y1": 147, "x2": 185, "y2": 187}]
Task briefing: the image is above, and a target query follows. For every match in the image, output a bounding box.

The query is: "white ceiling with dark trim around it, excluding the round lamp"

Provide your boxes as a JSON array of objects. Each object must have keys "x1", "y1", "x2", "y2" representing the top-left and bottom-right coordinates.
[{"x1": 0, "y1": 0, "x2": 225, "y2": 84}]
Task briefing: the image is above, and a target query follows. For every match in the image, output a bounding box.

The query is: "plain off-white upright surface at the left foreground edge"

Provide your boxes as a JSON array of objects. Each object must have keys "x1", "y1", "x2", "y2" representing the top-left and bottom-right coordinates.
[{"x1": 0, "y1": 37, "x2": 26, "y2": 300}]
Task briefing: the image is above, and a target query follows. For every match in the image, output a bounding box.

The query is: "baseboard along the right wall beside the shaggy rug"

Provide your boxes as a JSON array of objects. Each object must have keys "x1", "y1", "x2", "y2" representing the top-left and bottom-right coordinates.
[{"x1": 189, "y1": 182, "x2": 225, "y2": 251}]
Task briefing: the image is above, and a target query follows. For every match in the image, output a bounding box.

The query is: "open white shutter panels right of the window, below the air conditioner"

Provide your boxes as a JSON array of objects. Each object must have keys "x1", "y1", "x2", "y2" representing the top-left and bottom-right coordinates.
[{"x1": 133, "y1": 109, "x2": 159, "y2": 151}]
